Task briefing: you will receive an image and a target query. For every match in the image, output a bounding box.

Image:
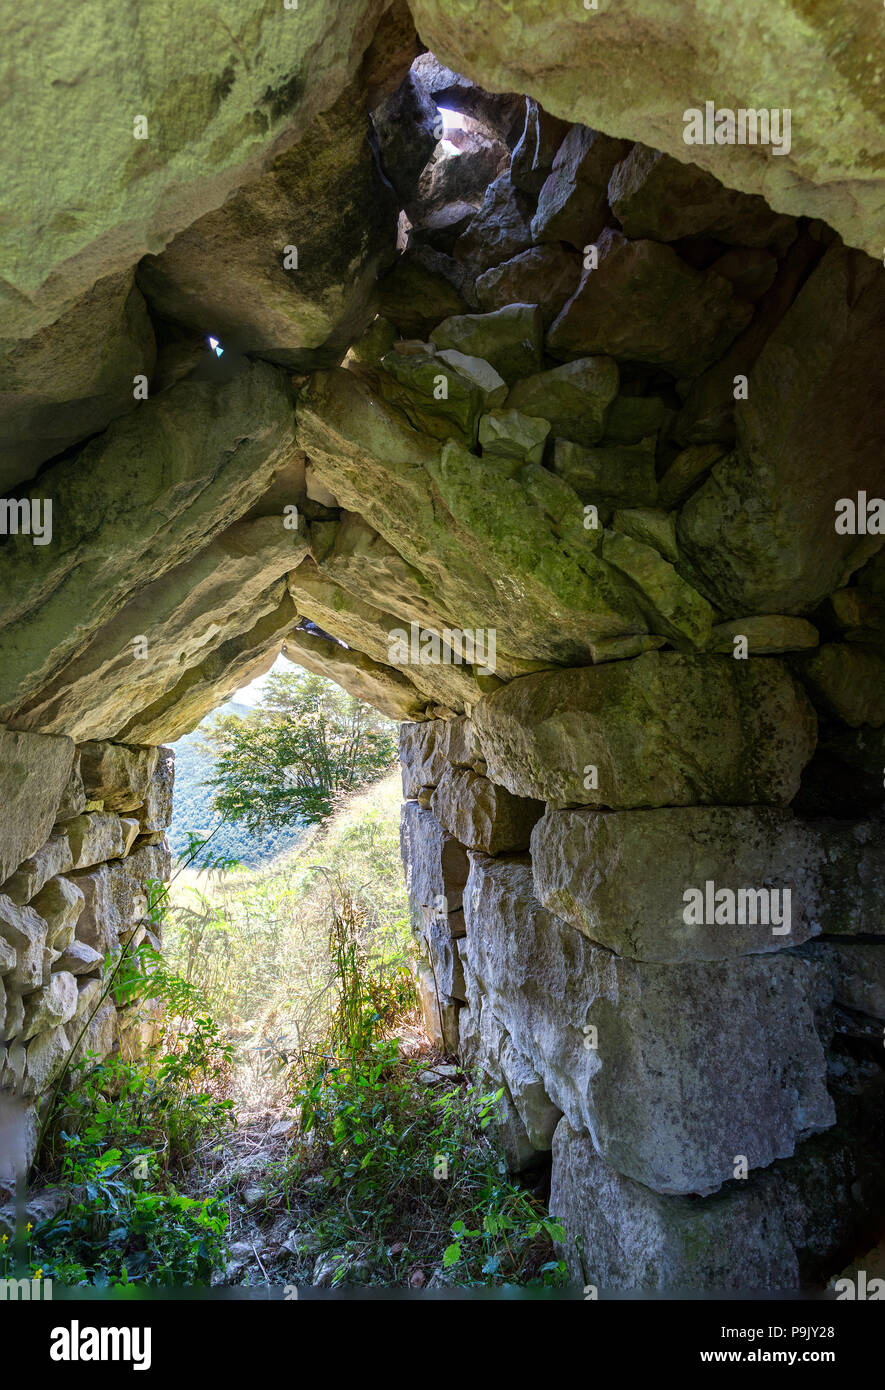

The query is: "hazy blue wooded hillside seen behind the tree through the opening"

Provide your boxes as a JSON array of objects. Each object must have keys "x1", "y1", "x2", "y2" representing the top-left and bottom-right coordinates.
[{"x1": 168, "y1": 701, "x2": 301, "y2": 869}]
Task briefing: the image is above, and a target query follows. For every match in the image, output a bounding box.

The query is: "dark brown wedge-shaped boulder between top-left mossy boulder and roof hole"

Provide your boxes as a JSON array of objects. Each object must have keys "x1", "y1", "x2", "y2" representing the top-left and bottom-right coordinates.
[{"x1": 139, "y1": 92, "x2": 397, "y2": 371}]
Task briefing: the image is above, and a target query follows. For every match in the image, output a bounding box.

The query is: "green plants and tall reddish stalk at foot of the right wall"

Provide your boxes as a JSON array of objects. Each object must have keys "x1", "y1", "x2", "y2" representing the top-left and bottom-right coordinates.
[{"x1": 284, "y1": 894, "x2": 565, "y2": 1286}]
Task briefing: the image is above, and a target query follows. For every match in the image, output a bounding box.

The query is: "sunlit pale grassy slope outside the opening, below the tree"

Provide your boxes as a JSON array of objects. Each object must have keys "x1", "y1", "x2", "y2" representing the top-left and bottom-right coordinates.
[{"x1": 163, "y1": 773, "x2": 410, "y2": 1056}]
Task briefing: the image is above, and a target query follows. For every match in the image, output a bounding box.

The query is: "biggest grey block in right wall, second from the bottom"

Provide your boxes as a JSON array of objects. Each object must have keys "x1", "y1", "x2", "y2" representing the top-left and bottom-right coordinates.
[{"x1": 464, "y1": 855, "x2": 834, "y2": 1193}]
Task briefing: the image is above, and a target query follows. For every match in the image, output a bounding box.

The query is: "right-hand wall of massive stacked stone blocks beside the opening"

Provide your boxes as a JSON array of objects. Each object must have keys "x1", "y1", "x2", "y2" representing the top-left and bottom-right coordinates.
[{"x1": 400, "y1": 717, "x2": 885, "y2": 1290}]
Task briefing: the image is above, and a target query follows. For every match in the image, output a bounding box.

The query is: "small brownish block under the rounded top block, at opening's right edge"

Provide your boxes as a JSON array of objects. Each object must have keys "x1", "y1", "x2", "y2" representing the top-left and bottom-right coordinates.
[{"x1": 431, "y1": 767, "x2": 543, "y2": 855}]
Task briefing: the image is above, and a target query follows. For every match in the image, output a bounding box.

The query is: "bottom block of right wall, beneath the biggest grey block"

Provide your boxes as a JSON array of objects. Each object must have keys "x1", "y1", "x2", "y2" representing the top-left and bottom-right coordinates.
[{"x1": 550, "y1": 1119, "x2": 885, "y2": 1297}]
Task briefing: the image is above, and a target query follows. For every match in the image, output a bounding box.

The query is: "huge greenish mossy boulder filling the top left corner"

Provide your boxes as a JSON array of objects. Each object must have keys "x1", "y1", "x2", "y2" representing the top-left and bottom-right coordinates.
[{"x1": 0, "y1": 0, "x2": 397, "y2": 338}]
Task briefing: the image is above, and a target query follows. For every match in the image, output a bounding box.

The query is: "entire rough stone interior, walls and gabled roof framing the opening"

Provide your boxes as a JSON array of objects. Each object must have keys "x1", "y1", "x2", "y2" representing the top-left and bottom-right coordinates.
[{"x1": 0, "y1": 10, "x2": 885, "y2": 1289}]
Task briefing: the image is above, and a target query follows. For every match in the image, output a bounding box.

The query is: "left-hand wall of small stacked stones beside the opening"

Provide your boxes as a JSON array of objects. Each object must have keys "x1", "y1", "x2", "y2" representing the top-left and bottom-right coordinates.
[{"x1": 0, "y1": 728, "x2": 174, "y2": 1180}]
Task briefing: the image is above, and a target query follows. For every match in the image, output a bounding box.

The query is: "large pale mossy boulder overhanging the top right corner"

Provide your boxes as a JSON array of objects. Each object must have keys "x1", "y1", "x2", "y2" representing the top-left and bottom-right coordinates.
[{"x1": 411, "y1": 0, "x2": 882, "y2": 259}]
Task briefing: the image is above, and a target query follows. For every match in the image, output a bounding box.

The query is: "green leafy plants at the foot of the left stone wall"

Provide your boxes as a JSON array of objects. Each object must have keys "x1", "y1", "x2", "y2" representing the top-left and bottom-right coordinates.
[{"x1": 29, "y1": 945, "x2": 235, "y2": 1287}]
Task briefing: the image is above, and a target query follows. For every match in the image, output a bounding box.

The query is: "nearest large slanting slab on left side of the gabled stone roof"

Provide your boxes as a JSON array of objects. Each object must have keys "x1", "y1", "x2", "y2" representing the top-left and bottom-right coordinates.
[{"x1": 0, "y1": 363, "x2": 295, "y2": 714}]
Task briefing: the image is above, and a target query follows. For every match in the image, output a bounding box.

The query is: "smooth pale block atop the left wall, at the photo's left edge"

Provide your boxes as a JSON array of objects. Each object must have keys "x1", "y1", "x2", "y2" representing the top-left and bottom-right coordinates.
[{"x1": 0, "y1": 727, "x2": 74, "y2": 883}]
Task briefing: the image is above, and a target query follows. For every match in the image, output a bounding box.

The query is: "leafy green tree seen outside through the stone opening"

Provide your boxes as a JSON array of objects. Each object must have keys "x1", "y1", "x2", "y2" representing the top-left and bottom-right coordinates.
[{"x1": 201, "y1": 671, "x2": 396, "y2": 835}]
